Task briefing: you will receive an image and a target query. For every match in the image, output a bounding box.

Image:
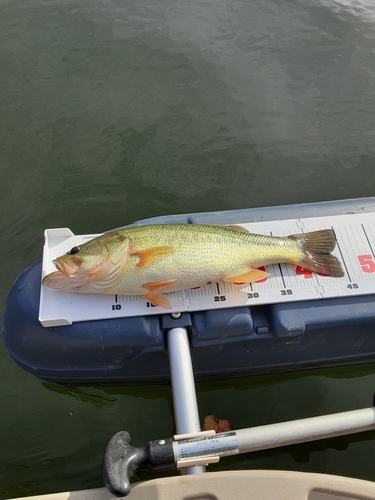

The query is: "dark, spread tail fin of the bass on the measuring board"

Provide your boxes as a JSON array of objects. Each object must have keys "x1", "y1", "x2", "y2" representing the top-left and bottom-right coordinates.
[{"x1": 289, "y1": 229, "x2": 345, "y2": 278}]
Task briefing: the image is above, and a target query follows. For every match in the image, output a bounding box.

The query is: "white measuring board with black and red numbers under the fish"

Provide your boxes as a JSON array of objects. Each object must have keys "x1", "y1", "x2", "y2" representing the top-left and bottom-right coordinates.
[{"x1": 39, "y1": 213, "x2": 375, "y2": 326}]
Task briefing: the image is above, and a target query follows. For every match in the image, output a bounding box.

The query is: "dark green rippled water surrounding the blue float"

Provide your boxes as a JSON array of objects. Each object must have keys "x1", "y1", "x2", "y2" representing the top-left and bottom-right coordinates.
[{"x1": 0, "y1": 0, "x2": 375, "y2": 498}]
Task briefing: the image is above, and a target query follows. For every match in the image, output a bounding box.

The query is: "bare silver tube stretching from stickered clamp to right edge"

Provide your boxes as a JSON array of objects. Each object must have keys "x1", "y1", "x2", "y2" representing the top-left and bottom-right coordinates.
[{"x1": 236, "y1": 408, "x2": 375, "y2": 453}]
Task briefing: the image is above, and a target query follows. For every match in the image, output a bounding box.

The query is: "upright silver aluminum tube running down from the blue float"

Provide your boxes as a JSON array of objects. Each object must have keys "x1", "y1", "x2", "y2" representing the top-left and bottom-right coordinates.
[{"x1": 167, "y1": 327, "x2": 206, "y2": 474}]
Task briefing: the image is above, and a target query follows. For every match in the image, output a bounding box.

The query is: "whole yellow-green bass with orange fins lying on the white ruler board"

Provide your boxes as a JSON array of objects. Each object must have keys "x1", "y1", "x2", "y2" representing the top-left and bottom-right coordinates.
[{"x1": 42, "y1": 224, "x2": 344, "y2": 309}]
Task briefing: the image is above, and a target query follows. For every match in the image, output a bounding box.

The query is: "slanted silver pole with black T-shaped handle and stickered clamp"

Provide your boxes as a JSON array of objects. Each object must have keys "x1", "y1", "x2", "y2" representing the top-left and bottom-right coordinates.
[{"x1": 103, "y1": 406, "x2": 375, "y2": 498}]
